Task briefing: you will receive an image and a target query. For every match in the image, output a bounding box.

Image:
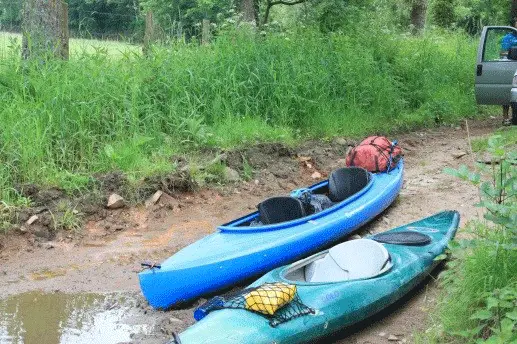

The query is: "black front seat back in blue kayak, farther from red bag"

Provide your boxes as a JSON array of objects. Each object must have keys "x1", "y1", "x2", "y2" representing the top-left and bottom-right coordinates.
[{"x1": 258, "y1": 197, "x2": 306, "y2": 225}]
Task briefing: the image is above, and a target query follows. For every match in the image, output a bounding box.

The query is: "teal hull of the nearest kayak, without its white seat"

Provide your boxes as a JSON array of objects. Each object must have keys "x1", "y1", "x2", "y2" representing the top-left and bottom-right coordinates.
[{"x1": 179, "y1": 211, "x2": 459, "y2": 344}]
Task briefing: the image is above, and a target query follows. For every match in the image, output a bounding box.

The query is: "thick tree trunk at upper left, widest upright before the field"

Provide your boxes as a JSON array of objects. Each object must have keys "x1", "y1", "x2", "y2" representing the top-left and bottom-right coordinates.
[{"x1": 22, "y1": 0, "x2": 69, "y2": 60}]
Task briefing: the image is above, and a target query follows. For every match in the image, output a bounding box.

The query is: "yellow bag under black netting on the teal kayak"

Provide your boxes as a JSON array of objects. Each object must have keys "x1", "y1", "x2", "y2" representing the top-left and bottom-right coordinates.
[{"x1": 244, "y1": 283, "x2": 296, "y2": 315}]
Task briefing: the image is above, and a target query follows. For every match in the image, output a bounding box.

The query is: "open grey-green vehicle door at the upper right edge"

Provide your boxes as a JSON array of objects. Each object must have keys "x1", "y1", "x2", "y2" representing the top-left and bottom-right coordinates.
[{"x1": 475, "y1": 26, "x2": 517, "y2": 105}]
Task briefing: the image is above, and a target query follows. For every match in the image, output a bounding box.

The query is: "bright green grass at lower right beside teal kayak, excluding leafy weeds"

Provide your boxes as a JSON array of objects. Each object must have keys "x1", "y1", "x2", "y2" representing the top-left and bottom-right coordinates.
[{"x1": 416, "y1": 223, "x2": 517, "y2": 344}]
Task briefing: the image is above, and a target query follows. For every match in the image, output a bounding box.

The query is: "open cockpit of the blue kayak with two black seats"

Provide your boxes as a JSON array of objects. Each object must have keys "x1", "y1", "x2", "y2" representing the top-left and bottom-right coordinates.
[{"x1": 218, "y1": 167, "x2": 373, "y2": 231}]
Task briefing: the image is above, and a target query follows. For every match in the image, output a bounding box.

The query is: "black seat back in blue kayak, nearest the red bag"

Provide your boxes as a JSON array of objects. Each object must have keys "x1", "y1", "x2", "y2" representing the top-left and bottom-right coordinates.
[{"x1": 329, "y1": 167, "x2": 370, "y2": 202}]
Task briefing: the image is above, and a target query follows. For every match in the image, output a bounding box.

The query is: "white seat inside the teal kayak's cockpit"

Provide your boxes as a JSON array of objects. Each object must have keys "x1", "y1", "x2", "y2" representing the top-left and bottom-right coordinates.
[{"x1": 305, "y1": 239, "x2": 391, "y2": 282}]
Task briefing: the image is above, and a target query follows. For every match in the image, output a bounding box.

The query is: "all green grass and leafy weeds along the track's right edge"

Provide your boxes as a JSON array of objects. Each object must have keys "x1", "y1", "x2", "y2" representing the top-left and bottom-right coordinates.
[{"x1": 428, "y1": 135, "x2": 517, "y2": 344}]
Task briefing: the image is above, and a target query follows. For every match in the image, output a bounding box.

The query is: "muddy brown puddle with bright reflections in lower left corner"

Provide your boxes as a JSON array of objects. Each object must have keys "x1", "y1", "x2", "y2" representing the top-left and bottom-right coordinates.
[{"x1": 0, "y1": 292, "x2": 148, "y2": 344}]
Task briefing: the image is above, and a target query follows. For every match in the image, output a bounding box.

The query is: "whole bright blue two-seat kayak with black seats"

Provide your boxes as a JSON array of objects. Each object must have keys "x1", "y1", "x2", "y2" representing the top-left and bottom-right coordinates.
[{"x1": 139, "y1": 159, "x2": 404, "y2": 309}]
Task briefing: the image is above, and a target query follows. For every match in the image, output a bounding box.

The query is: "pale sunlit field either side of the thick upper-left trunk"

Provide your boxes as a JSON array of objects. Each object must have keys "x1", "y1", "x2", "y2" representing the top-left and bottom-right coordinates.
[{"x1": 0, "y1": 31, "x2": 142, "y2": 59}]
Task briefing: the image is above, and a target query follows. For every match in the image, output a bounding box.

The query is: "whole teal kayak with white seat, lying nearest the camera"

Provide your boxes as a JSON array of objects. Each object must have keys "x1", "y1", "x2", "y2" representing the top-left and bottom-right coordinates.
[{"x1": 173, "y1": 211, "x2": 459, "y2": 344}]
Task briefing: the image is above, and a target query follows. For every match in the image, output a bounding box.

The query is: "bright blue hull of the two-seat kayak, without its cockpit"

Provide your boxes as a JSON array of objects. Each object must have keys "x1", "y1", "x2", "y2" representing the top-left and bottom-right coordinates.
[{"x1": 139, "y1": 160, "x2": 404, "y2": 309}]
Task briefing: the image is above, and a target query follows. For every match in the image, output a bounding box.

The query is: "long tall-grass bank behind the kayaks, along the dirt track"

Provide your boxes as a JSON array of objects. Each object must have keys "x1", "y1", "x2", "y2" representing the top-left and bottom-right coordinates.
[{"x1": 0, "y1": 30, "x2": 476, "y2": 200}]
